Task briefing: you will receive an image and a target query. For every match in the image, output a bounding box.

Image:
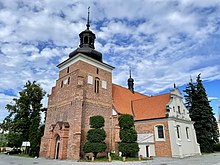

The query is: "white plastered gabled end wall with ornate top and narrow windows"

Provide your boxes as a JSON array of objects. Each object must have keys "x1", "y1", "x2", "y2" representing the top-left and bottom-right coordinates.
[{"x1": 167, "y1": 88, "x2": 201, "y2": 158}]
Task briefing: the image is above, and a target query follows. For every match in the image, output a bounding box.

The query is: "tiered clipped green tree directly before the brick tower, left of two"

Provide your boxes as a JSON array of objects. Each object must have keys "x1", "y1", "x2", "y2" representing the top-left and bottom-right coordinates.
[{"x1": 83, "y1": 116, "x2": 107, "y2": 158}]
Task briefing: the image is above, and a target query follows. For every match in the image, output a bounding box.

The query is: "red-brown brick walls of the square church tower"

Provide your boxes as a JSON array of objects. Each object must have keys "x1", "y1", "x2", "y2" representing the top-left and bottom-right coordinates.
[{"x1": 40, "y1": 58, "x2": 112, "y2": 159}]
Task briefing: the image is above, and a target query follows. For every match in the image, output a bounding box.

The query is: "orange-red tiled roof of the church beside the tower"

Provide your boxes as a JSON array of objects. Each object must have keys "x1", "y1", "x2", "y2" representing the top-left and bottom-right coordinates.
[{"x1": 112, "y1": 84, "x2": 170, "y2": 120}]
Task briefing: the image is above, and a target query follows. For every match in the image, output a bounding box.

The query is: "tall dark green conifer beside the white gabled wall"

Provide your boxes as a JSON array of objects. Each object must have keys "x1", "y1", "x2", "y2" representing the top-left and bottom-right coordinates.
[{"x1": 184, "y1": 74, "x2": 218, "y2": 152}]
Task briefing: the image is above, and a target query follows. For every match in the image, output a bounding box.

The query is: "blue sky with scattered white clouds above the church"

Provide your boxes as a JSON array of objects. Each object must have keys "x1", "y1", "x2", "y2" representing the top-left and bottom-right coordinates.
[{"x1": 0, "y1": 0, "x2": 220, "y2": 122}]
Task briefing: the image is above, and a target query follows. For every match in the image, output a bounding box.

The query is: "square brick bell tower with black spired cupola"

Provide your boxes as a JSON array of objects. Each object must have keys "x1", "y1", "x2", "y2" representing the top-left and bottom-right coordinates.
[{"x1": 40, "y1": 7, "x2": 114, "y2": 160}]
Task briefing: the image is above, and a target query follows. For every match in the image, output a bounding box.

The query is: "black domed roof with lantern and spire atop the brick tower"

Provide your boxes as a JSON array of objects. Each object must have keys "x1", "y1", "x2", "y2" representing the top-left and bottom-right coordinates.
[{"x1": 69, "y1": 7, "x2": 102, "y2": 62}]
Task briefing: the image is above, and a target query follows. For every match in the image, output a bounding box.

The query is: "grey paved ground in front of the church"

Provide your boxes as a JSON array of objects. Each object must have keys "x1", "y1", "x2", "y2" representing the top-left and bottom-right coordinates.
[{"x1": 0, "y1": 152, "x2": 220, "y2": 165}]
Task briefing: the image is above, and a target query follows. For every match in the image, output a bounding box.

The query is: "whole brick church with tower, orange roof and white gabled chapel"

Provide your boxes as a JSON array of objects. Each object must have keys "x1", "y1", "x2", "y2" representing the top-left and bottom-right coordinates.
[{"x1": 40, "y1": 13, "x2": 201, "y2": 160}]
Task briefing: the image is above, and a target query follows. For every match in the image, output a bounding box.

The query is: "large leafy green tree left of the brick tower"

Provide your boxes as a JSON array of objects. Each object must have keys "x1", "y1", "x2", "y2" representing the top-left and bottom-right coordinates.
[{"x1": 3, "y1": 81, "x2": 46, "y2": 156}]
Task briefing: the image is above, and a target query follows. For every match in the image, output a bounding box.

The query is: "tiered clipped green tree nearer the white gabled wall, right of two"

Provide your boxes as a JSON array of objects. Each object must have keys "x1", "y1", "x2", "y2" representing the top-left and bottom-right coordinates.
[{"x1": 118, "y1": 114, "x2": 139, "y2": 156}]
